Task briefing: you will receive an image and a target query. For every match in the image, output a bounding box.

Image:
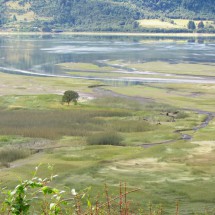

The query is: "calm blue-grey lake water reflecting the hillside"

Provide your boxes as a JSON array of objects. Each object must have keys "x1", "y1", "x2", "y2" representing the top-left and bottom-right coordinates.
[{"x1": 0, "y1": 35, "x2": 215, "y2": 82}]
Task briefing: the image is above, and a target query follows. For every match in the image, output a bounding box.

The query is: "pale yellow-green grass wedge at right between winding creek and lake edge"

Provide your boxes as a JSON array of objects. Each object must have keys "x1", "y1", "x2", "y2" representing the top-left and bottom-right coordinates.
[{"x1": 105, "y1": 84, "x2": 215, "y2": 111}]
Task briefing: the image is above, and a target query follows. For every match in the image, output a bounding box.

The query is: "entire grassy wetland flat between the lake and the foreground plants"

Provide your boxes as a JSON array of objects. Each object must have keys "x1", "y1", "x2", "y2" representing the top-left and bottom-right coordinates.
[{"x1": 0, "y1": 35, "x2": 215, "y2": 215}]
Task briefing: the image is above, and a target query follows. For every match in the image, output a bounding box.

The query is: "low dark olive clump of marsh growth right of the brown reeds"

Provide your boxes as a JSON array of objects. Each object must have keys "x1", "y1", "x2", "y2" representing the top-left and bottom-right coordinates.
[{"x1": 87, "y1": 132, "x2": 123, "y2": 146}]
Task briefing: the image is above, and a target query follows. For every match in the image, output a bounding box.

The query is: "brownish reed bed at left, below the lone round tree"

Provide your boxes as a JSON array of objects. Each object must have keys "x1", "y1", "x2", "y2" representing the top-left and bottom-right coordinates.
[{"x1": 0, "y1": 110, "x2": 127, "y2": 139}]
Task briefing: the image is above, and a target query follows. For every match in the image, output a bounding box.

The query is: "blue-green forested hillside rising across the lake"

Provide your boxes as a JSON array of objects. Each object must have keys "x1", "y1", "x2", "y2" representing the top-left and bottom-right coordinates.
[{"x1": 0, "y1": 0, "x2": 215, "y2": 31}]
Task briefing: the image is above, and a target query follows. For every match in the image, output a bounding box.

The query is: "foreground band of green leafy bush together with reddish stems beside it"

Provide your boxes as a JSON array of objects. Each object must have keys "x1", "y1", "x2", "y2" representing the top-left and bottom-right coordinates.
[{"x1": 0, "y1": 166, "x2": 140, "y2": 215}]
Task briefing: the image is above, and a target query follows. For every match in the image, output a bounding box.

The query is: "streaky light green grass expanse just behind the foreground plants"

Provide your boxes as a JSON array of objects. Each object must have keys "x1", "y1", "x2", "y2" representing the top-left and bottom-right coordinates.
[{"x1": 1, "y1": 141, "x2": 214, "y2": 215}]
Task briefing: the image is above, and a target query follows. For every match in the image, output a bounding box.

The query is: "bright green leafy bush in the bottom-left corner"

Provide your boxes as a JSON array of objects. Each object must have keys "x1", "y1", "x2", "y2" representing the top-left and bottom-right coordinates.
[{"x1": 0, "y1": 168, "x2": 72, "y2": 215}]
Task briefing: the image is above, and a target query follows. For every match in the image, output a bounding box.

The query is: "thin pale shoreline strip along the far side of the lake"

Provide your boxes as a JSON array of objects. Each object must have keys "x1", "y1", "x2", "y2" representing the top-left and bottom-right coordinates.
[{"x1": 0, "y1": 31, "x2": 215, "y2": 38}]
